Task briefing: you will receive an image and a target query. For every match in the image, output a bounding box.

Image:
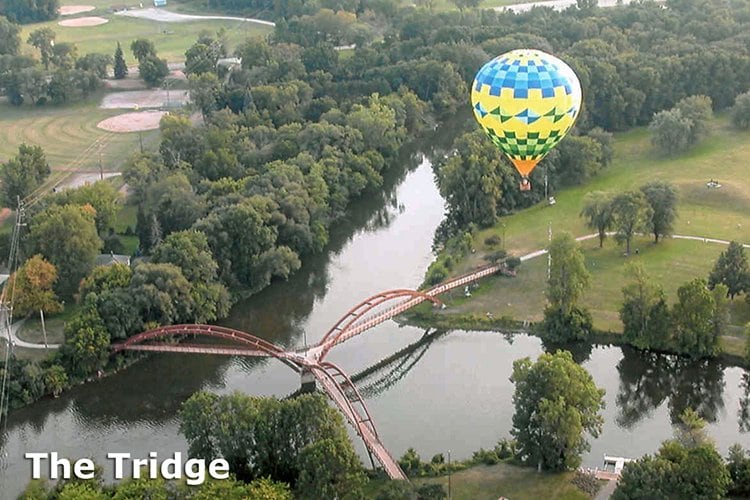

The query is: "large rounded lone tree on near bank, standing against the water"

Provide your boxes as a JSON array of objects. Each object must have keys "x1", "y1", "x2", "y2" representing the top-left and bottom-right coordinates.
[{"x1": 510, "y1": 351, "x2": 604, "y2": 471}]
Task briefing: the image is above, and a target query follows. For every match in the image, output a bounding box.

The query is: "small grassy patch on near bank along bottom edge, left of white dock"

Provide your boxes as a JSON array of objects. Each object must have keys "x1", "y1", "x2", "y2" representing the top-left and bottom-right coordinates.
[{"x1": 369, "y1": 463, "x2": 589, "y2": 500}]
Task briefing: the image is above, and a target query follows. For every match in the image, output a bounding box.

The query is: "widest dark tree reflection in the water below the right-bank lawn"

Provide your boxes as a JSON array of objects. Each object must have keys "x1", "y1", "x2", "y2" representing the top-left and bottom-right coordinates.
[{"x1": 617, "y1": 347, "x2": 725, "y2": 429}]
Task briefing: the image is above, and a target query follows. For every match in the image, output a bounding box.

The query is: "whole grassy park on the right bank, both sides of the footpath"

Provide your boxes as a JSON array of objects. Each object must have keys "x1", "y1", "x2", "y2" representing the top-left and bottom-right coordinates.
[{"x1": 428, "y1": 117, "x2": 750, "y2": 350}]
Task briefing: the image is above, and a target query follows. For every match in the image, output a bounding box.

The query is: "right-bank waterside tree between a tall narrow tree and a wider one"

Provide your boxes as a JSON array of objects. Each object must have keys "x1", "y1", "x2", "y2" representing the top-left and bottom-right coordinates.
[{"x1": 620, "y1": 262, "x2": 670, "y2": 349}]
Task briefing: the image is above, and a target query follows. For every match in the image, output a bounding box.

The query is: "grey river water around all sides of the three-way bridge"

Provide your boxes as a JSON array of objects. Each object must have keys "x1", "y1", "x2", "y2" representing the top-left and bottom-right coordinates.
[{"x1": 0, "y1": 129, "x2": 750, "y2": 499}]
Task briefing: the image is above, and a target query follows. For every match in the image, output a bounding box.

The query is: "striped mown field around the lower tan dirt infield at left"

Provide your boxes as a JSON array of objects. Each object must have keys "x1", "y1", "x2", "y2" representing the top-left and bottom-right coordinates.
[{"x1": 0, "y1": 97, "x2": 159, "y2": 171}]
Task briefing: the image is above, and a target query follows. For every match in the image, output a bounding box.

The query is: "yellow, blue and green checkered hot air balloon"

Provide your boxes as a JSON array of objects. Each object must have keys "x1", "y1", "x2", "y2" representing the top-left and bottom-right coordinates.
[{"x1": 471, "y1": 49, "x2": 581, "y2": 191}]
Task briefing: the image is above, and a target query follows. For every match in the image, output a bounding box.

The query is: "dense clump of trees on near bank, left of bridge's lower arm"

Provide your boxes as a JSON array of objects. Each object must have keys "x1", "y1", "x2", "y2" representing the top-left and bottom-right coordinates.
[{"x1": 180, "y1": 392, "x2": 362, "y2": 486}]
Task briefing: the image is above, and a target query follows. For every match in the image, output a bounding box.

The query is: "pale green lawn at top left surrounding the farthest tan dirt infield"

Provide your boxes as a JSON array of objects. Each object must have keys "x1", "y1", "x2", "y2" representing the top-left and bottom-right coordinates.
[{"x1": 21, "y1": 11, "x2": 272, "y2": 65}]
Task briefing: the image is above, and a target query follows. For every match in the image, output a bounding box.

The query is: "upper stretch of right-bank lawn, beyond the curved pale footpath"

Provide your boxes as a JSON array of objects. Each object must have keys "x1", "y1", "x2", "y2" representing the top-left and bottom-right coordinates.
[{"x1": 470, "y1": 117, "x2": 750, "y2": 264}]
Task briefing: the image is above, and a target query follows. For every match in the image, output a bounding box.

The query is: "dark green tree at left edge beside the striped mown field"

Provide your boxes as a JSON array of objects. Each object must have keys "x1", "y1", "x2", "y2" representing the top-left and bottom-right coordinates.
[{"x1": 0, "y1": 144, "x2": 50, "y2": 207}]
